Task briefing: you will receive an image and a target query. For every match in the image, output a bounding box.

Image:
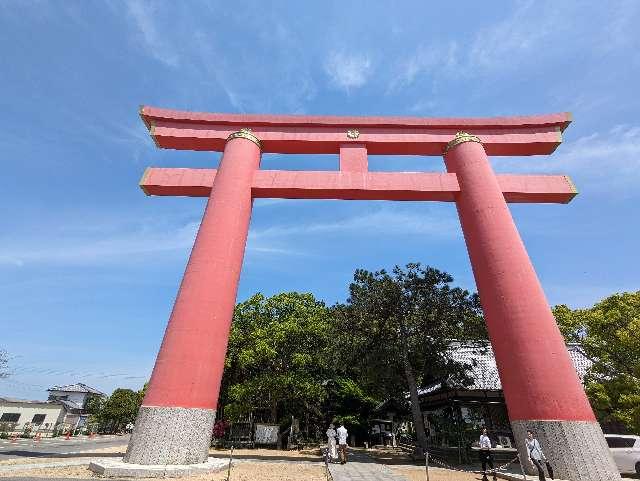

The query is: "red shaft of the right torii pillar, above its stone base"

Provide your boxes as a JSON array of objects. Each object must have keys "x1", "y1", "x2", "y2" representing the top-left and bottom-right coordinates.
[{"x1": 445, "y1": 142, "x2": 595, "y2": 421}]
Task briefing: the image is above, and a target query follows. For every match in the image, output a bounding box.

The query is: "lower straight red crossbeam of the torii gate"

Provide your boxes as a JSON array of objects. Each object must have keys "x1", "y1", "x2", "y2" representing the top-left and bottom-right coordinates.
[{"x1": 140, "y1": 167, "x2": 577, "y2": 204}]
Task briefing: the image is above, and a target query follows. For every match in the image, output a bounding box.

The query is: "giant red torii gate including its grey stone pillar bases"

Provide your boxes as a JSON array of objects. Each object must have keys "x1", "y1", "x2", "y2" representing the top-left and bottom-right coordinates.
[{"x1": 125, "y1": 107, "x2": 619, "y2": 481}]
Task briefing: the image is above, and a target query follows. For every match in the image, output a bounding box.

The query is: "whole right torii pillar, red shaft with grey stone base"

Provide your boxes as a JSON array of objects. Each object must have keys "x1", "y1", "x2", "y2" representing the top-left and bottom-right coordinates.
[{"x1": 444, "y1": 133, "x2": 620, "y2": 481}]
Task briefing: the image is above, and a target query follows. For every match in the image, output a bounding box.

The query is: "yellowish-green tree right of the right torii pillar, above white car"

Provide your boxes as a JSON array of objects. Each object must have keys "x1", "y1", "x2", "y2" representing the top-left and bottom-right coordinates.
[{"x1": 553, "y1": 291, "x2": 640, "y2": 434}]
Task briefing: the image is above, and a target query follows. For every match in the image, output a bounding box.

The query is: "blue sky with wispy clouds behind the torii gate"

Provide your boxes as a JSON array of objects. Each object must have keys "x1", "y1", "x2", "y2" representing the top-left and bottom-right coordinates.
[{"x1": 0, "y1": 0, "x2": 640, "y2": 399}]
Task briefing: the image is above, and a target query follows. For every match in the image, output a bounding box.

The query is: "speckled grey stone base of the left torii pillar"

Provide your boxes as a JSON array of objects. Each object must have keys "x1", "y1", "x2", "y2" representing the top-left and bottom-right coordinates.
[{"x1": 124, "y1": 406, "x2": 216, "y2": 465}]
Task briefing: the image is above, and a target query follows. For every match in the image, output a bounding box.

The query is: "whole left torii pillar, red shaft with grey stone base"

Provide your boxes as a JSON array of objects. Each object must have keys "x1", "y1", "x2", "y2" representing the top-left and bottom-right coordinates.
[{"x1": 124, "y1": 132, "x2": 260, "y2": 465}]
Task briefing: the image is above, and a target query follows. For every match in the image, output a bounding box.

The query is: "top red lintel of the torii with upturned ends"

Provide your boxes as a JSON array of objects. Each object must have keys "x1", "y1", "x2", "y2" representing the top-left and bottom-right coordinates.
[{"x1": 140, "y1": 106, "x2": 571, "y2": 156}]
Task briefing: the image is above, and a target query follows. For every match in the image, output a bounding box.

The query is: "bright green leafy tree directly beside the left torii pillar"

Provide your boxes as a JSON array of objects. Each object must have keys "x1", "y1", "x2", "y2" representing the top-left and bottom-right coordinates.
[{"x1": 221, "y1": 292, "x2": 331, "y2": 422}]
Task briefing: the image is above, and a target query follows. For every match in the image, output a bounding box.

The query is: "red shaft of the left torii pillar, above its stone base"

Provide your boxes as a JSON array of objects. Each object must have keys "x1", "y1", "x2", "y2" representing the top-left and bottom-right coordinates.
[{"x1": 143, "y1": 138, "x2": 260, "y2": 409}]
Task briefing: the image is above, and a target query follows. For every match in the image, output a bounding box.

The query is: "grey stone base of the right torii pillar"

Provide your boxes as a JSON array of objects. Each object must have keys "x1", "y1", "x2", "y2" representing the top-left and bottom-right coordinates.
[{"x1": 511, "y1": 421, "x2": 621, "y2": 481}]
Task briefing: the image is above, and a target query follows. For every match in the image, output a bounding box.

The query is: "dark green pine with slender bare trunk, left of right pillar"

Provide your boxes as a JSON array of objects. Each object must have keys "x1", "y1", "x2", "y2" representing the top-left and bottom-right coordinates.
[{"x1": 336, "y1": 263, "x2": 486, "y2": 448}]
